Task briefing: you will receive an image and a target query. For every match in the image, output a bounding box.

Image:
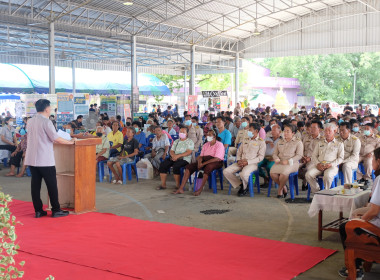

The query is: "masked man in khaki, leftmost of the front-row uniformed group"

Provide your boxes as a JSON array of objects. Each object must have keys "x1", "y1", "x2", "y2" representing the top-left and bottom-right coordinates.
[{"x1": 223, "y1": 123, "x2": 266, "y2": 196}]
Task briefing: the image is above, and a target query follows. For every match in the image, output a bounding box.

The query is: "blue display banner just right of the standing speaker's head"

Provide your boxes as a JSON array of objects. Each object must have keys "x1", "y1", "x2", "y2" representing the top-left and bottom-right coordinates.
[{"x1": 57, "y1": 92, "x2": 74, "y2": 129}]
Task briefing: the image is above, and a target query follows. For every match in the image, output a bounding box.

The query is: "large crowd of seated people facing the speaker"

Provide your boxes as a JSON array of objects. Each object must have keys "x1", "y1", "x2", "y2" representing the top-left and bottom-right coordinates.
[{"x1": 0, "y1": 100, "x2": 380, "y2": 198}]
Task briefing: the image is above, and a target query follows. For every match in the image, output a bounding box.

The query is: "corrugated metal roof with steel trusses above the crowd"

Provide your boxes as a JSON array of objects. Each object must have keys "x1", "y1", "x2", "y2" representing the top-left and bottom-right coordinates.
[{"x1": 0, "y1": 0, "x2": 377, "y2": 71}]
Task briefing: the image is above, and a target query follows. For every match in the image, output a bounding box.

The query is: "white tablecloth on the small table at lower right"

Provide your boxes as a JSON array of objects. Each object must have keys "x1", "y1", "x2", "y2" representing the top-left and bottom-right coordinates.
[{"x1": 308, "y1": 186, "x2": 371, "y2": 217}]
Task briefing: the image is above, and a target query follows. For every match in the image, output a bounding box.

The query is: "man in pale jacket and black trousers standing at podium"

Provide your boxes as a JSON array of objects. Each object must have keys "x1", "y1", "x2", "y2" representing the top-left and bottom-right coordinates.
[{"x1": 25, "y1": 99, "x2": 75, "y2": 218}]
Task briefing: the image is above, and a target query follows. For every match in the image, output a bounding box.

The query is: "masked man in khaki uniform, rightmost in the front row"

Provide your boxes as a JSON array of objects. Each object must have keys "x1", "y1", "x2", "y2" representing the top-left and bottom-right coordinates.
[{"x1": 358, "y1": 122, "x2": 380, "y2": 183}]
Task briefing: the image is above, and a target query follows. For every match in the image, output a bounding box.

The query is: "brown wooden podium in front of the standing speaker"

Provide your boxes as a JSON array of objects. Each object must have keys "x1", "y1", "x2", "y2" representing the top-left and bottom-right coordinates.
[{"x1": 49, "y1": 138, "x2": 102, "y2": 214}]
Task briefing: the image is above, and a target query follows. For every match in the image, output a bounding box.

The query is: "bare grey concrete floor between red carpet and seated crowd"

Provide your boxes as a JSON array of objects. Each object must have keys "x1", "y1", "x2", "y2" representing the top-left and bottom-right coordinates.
[{"x1": 0, "y1": 169, "x2": 380, "y2": 280}]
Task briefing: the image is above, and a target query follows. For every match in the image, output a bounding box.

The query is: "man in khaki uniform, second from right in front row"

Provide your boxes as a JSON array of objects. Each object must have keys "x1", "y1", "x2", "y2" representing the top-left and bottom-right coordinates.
[{"x1": 337, "y1": 122, "x2": 361, "y2": 184}]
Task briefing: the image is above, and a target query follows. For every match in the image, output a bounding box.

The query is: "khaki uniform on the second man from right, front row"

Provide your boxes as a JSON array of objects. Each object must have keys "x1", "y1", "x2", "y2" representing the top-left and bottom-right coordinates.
[{"x1": 337, "y1": 134, "x2": 361, "y2": 184}]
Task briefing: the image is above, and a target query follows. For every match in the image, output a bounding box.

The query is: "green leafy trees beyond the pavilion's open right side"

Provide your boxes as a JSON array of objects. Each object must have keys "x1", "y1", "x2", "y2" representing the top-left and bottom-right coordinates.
[{"x1": 254, "y1": 53, "x2": 380, "y2": 104}]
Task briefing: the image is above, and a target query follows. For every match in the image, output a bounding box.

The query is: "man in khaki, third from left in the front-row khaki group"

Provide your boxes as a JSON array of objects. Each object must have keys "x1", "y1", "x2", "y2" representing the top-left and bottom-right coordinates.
[{"x1": 298, "y1": 120, "x2": 323, "y2": 191}]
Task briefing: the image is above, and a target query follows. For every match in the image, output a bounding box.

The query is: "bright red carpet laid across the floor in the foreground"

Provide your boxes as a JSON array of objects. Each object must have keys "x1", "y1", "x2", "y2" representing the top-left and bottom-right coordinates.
[{"x1": 11, "y1": 201, "x2": 335, "y2": 280}]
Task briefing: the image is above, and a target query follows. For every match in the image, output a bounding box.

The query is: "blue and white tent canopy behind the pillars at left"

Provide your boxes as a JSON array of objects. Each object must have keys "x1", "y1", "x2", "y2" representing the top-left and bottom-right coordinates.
[{"x1": 0, "y1": 63, "x2": 171, "y2": 95}]
